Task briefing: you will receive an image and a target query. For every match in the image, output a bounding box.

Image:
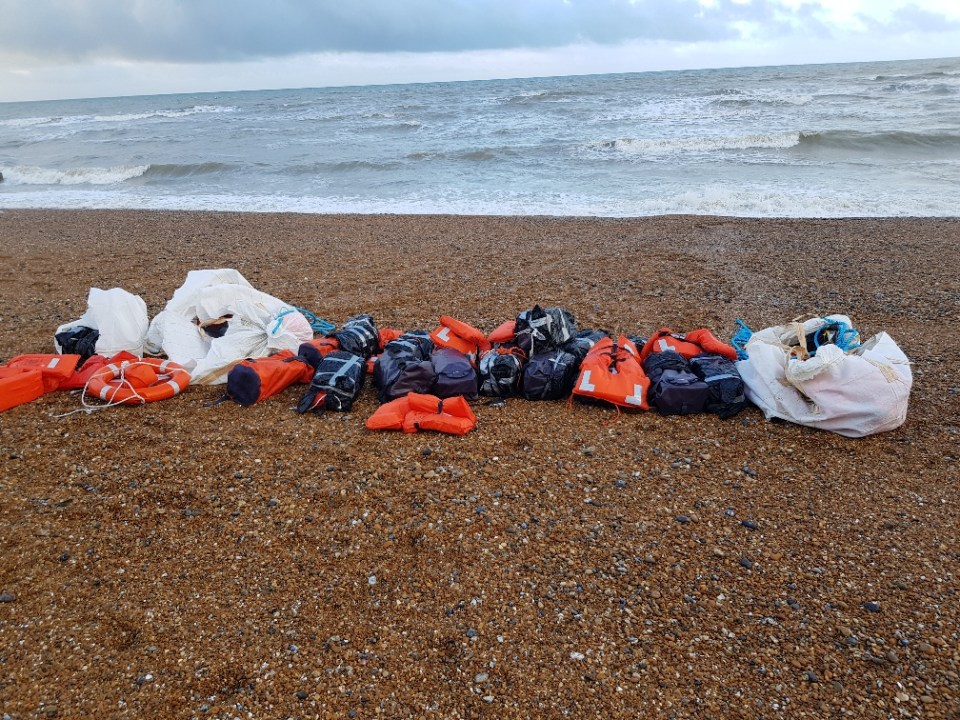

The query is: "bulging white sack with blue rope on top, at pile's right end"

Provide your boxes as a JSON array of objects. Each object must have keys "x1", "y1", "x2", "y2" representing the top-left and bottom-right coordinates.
[{"x1": 737, "y1": 315, "x2": 913, "y2": 437}]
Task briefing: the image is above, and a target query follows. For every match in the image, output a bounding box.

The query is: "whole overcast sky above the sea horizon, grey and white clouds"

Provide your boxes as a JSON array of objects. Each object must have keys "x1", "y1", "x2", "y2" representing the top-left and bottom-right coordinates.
[{"x1": 0, "y1": 0, "x2": 960, "y2": 102}]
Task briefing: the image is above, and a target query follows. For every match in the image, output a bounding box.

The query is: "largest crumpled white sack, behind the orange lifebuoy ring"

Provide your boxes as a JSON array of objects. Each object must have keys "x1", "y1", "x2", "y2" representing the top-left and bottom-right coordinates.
[{"x1": 147, "y1": 269, "x2": 313, "y2": 385}]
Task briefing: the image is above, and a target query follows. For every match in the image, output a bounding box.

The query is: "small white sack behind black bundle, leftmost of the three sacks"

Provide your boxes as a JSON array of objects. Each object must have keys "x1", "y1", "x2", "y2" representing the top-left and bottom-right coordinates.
[{"x1": 53, "y1": 288, "x2": 148, "y2": 357}]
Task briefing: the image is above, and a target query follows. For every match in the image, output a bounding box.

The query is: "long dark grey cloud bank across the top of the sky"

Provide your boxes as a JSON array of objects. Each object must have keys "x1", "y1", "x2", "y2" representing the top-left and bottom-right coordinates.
[{"x1": 0, "y1": 0, "x2": 815, "y2": 62}]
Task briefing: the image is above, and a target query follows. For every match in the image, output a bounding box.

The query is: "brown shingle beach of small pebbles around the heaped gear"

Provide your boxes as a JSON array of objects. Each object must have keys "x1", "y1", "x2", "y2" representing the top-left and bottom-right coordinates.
[{"x1": 0, "y1": 210, "x2": 960, "y2": 720}]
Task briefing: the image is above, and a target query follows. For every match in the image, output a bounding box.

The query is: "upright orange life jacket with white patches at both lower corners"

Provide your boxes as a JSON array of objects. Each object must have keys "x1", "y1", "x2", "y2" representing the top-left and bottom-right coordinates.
[{"x1": 573, "y1": 335, "x2": 650, "y2": 410}]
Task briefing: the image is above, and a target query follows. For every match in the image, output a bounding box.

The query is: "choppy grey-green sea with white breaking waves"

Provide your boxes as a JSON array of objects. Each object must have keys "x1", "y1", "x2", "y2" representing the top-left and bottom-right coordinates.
[{"x1": 0, "y1": 58, "x2": 960, "y2": 218}]
